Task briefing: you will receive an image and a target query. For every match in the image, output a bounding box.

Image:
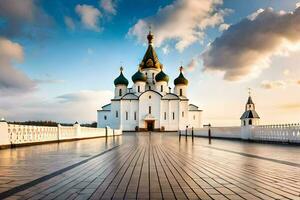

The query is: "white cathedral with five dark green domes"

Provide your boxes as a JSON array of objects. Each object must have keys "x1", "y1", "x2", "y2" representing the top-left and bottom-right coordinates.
[{"x1": 97, "y1": 31, "x2": 202, "y2": 131}]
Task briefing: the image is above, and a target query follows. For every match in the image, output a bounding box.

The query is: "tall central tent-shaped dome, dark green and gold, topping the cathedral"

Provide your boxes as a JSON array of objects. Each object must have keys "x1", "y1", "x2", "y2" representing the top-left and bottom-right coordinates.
[{"x1": 140, "y1": 31, "x2": 161, "y2": 69}]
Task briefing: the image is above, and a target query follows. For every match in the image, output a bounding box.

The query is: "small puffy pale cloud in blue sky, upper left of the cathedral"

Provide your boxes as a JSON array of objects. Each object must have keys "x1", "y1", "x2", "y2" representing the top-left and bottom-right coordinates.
[{"x1": 75, "y1": 4, "x2": 102, "y2": 32}]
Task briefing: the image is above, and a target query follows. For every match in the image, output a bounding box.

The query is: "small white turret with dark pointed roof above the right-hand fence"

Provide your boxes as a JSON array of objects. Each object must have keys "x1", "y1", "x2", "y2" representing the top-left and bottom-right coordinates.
[{"x1": 240, "y1": 93, "x2": 260, "y2": 126}]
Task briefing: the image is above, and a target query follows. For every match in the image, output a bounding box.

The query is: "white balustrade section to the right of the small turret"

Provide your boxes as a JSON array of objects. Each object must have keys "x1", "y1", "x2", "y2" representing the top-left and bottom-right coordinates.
[{"x1": 251, "y1": 124, "x2": 300, "y2": 143}]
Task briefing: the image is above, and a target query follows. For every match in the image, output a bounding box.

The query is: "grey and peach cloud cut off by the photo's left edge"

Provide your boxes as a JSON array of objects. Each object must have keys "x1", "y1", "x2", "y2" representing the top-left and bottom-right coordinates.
[{"x1": 0, "y1": 38, "x2": 36, "y2": 95}]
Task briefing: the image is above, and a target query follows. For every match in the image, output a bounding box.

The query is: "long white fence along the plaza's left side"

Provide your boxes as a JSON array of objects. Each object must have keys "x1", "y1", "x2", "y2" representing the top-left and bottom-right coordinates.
[{"x1": 0, "y1": 121, "x2": 122, "y2": 146}]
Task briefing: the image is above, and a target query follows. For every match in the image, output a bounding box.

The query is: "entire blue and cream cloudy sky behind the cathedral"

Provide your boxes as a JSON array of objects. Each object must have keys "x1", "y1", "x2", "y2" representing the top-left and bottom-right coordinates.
[{"x1": 0, "y1": 0, "x2": 300, "y2": 126}]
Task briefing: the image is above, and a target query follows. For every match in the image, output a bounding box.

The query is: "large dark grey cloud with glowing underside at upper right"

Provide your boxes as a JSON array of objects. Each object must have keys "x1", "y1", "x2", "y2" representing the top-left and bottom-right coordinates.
[{"x1": 202, "y1": 8, "x2": 300, "y2": 81}]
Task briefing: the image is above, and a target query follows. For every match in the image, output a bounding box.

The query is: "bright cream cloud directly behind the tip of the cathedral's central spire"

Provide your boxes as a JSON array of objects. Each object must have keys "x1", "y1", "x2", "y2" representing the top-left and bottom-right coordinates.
[{"x1": 128, "y1": 0, "x2": 229, "y2": 51}]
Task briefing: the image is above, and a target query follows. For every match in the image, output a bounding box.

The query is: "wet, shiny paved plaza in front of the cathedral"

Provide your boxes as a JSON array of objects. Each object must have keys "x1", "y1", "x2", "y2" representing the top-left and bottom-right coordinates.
[{"x1": 0, "y1": 133, "x2": 300, "y2": 199}]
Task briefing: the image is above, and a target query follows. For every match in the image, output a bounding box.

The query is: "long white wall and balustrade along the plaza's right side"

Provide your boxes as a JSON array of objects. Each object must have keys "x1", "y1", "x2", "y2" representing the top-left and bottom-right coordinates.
[{"x1": 181, "y1": 124, "x2": 300, "y2": 144}]
